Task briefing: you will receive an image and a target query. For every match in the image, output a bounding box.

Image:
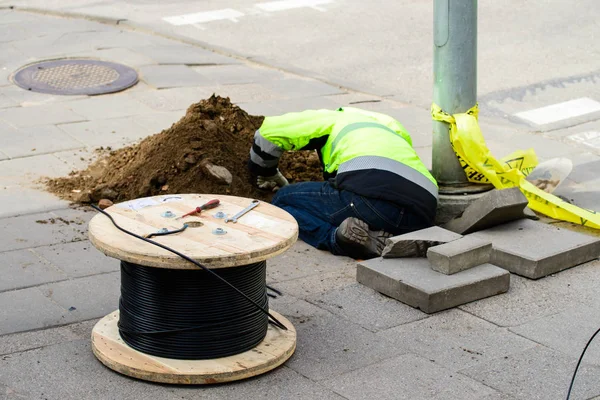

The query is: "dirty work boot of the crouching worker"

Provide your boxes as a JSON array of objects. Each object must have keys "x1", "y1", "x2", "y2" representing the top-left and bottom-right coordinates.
[{"x1": 335, "y1": 217, "x2": 392, "y2": 260}]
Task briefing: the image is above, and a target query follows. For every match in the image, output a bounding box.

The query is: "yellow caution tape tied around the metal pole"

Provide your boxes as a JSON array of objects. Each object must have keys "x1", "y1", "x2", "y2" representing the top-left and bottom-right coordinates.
[{"x1": 431, "y1": 104, "x2": 600, "y2": 229}]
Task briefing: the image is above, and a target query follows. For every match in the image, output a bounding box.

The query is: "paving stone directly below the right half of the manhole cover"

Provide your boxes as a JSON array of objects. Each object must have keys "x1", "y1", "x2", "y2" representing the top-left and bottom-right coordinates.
[{"x1": 64, "y1": 96, "x2": 152, "y2": 120}]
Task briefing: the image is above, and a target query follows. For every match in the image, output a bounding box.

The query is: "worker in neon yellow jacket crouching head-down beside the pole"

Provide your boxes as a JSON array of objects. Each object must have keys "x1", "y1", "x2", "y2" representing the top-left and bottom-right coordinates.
[{"x1": 249, "y1": 107, "x2": 438, "y2": 259}]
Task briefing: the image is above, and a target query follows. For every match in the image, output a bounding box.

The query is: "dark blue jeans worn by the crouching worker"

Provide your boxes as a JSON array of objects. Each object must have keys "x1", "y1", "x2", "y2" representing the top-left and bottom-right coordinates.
[{"x1": 272, "y1": 182, "x2": 429, "y2": 255}]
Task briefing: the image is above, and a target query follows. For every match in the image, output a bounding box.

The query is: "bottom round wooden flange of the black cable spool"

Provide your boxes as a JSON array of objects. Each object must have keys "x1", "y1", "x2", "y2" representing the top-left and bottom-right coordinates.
[{"x1": 92, "y1": 311, "x2": 296, "y2": 384}]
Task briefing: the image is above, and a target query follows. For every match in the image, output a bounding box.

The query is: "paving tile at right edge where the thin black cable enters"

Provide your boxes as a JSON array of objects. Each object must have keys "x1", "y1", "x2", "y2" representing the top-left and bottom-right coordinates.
[{"x1": 510, "y1": 305, "x2": 600, "y2": 365}]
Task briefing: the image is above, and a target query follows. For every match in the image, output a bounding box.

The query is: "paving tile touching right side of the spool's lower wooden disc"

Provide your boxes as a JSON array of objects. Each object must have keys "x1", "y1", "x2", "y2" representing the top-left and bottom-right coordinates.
[{"x1": 270, "y1": 296, "x2": 406, "y2": 381}]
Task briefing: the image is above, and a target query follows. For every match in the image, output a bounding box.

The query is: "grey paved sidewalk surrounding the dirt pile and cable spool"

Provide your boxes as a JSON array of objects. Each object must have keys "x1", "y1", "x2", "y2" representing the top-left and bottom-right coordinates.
[{"x1": 0, "y1": 10, "x2": 600, "y2": 400}]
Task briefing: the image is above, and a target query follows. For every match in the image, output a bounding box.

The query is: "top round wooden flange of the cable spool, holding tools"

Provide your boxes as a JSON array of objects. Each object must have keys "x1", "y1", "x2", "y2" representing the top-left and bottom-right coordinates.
[{"x1": 88, "y1": 194, "x2": 298, "y2": 269}]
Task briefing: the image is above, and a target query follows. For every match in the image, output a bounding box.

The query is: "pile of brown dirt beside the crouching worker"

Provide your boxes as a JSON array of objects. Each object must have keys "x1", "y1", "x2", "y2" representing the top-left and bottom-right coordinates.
[{"x1": 46, "y1": 95, "x2": 322, "y2": 203}]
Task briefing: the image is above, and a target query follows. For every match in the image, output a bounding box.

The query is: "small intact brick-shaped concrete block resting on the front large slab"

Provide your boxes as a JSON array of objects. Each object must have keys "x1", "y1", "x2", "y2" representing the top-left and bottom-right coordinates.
[{"x1": 427, "y1": 236, "x2": 492, "y2": 275}]
